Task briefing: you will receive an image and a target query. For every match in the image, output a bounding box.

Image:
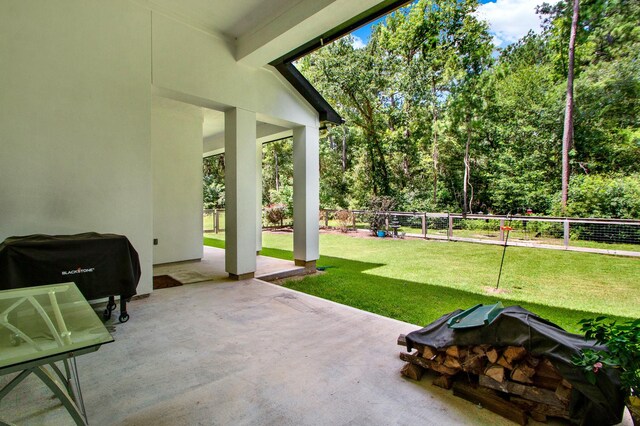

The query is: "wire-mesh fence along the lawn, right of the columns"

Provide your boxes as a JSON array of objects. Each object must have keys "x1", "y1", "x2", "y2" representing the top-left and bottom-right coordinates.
[{"x1": 320, "y1": 210, "x2": 640, "y2": 256}]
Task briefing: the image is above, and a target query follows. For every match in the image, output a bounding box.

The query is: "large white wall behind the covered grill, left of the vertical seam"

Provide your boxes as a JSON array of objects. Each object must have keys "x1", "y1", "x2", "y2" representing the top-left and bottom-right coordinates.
[{"x1": 0, "y1": 0, "x2": 152, "y2": 294}]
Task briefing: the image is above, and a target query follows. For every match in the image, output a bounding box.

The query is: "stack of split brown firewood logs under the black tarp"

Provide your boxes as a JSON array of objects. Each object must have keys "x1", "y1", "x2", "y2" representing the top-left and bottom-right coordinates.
[{"x1": 398, "y1": 334, "x2": 572, "y2": 425}]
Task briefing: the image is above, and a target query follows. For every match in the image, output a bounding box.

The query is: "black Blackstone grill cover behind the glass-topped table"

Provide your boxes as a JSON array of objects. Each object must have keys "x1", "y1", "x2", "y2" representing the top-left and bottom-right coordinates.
[{"x1": 0, "y1": 232, "x2": 140, "y2": 300}]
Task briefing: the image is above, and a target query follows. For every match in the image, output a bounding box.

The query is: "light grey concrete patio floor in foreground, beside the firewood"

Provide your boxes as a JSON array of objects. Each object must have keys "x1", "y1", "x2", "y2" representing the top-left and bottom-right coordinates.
[{"x1": 0, "y1": 248, "x2": 632, "y2": 426}]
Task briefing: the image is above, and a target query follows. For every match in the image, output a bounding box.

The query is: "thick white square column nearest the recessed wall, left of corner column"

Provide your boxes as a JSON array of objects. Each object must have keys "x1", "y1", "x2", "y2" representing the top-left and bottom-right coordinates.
[{"x1": 224, "y1": 108, "x2": 257, "y2": 279}]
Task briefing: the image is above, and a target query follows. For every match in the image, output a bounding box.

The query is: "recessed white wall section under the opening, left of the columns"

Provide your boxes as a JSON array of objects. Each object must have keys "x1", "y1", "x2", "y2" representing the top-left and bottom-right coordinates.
[{"x1": 151, "y1": 98, "x2": 202, "y2": 264}]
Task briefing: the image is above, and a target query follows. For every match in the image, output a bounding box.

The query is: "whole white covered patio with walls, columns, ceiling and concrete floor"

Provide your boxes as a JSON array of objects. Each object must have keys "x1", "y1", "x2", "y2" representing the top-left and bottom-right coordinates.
[{"x1": 5, "y1": 0, "x2": 636, "y2": 425}]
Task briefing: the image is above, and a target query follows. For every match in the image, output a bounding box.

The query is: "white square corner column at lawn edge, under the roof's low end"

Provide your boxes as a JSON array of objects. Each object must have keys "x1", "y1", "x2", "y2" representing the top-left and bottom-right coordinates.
[{"x1": 293, "y1": 126, "x2": 320, "y2": 271}]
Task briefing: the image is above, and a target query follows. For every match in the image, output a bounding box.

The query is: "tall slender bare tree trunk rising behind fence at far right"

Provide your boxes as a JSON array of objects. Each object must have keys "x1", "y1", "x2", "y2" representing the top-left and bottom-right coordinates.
[{"x1": 562, "y1": 0, "x2": 580, "y2": 213}]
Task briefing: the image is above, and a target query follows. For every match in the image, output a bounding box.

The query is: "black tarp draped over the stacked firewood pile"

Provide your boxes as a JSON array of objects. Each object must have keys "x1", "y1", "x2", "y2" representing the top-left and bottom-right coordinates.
[{"x1": 406, "y1": 306, "x2": 625, "y2": 425}]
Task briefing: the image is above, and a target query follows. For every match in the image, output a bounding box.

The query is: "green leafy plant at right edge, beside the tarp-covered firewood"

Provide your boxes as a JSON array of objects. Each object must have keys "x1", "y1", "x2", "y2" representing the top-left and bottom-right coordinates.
[{"x1": 573, "y1": 316, "x2": 640, "y2": 396}]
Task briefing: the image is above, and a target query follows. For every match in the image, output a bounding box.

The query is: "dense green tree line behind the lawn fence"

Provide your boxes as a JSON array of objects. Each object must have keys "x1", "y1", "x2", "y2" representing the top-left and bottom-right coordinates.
[{"x1": 299, "y1": 0, "x2": 640, "y2": 218}]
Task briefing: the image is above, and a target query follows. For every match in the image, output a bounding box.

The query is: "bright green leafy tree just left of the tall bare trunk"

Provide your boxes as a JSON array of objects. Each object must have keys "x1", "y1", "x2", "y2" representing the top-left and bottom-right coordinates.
[{"x1": 474, "y1": 34, "x2": 563, "y2": 214}]
